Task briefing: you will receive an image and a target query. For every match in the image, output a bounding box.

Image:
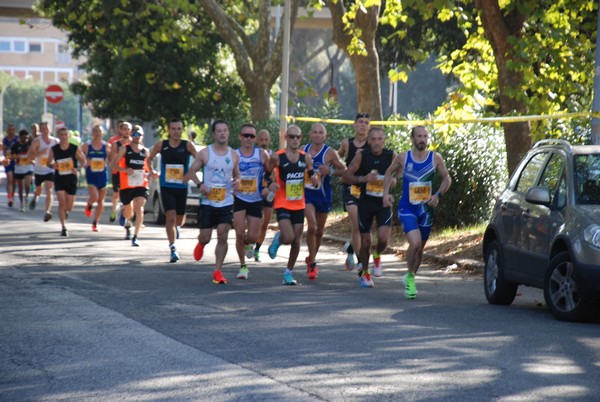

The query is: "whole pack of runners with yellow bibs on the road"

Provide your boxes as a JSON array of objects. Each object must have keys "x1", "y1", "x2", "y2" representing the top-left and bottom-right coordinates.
[{"x1": 3, "y1": 113, "x2": 451, "y2": 298}]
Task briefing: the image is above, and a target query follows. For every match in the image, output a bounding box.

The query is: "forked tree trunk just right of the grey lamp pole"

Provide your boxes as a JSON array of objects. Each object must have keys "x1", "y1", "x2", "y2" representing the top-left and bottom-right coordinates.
[{"x1": 326, "y1": 0, "x2": 383, "y2": 120}]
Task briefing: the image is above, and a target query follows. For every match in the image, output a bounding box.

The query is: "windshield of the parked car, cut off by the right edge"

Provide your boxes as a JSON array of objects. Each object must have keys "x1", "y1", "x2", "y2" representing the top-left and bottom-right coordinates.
[{"x1": 574, "y1": 154, "x2": 600, "y2": 205}]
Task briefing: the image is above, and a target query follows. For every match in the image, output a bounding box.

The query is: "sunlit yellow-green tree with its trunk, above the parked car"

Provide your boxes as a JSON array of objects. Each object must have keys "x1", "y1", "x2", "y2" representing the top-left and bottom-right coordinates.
[{"x1": 332, "y1": 0, "x2": 598, "y2": 172}]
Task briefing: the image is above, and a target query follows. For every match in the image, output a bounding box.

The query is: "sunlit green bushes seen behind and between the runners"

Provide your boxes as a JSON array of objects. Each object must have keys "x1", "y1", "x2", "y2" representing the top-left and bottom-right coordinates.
[{"x1": 195, "y1": 102, "x2": 508, "y2": 228}]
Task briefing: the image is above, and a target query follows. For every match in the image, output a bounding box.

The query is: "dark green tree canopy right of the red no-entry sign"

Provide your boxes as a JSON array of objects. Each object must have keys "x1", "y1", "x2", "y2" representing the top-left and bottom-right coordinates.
[{"x1": 38, "y1": 0, "x2": 247, "y2": 122}]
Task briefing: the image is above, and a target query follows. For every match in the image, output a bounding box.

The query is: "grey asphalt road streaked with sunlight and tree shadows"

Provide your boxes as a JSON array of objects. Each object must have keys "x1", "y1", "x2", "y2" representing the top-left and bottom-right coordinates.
[{"x1": 0, "y1": 195, "x2": 600, "y2": 401}]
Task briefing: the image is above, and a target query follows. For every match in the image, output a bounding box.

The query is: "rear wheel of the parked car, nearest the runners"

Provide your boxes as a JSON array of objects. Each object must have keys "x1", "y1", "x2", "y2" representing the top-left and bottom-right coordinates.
[{"x1": 483, "y1": 240, "x2": 518, "y2": 306}]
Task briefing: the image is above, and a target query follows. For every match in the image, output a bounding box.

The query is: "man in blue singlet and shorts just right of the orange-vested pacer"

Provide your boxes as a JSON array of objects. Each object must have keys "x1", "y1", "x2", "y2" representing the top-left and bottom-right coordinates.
[{"x1": 303, "y1": 123, "x2": 346, "y2": 279}]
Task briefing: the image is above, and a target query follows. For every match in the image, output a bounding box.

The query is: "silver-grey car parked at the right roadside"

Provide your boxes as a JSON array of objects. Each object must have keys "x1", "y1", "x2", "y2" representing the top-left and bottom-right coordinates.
[{"x1": 483, "y1": 140, "x2": 600, "y2": 321}]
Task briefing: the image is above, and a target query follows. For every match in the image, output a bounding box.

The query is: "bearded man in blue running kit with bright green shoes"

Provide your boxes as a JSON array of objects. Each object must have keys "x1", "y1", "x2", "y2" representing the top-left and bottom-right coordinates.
[{"x1": 384, "y1": 126, "x2": 452, "y2": 299}]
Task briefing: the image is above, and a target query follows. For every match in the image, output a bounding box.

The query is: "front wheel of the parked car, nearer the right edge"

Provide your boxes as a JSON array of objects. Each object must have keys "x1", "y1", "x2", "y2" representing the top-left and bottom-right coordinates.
[{"x1": 544, "y1": 251, "x2": 589, "y2": 321}]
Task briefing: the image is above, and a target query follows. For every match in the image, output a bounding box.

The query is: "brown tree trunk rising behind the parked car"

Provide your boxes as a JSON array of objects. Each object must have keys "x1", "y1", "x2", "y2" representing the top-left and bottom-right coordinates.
[{"x1": 475, "y1": 0, "x2": 532, "y2": 175}]
